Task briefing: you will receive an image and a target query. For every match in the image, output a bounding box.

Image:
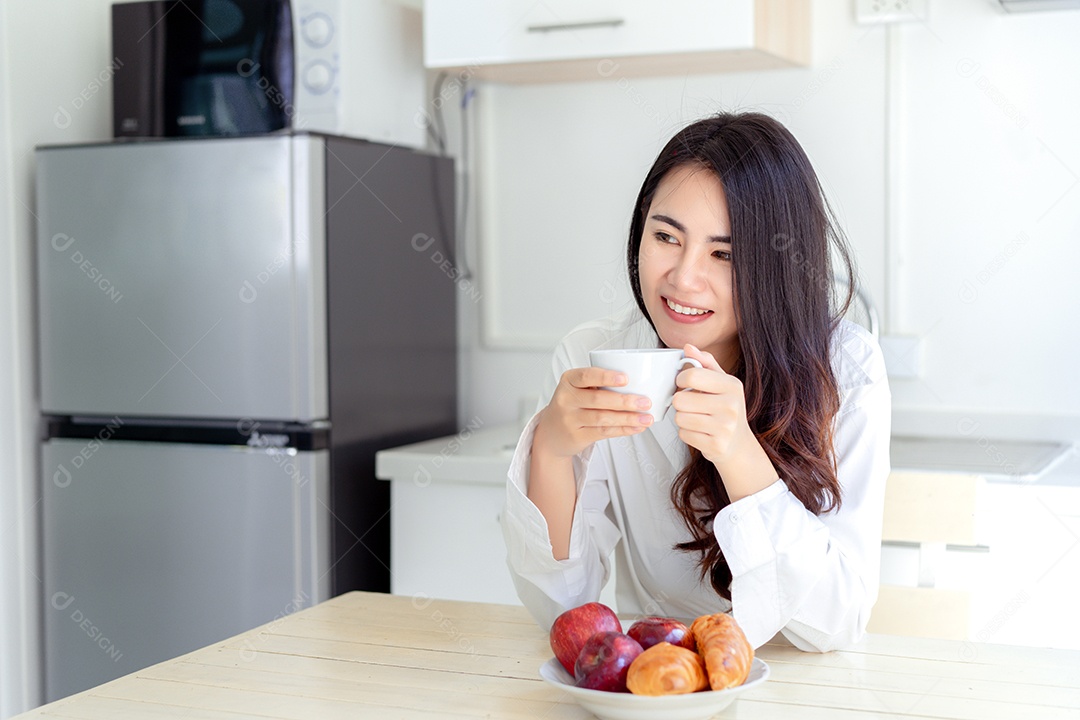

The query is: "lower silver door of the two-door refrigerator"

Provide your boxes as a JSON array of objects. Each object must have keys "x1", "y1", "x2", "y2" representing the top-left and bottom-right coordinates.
[{"x1": 42, "y1": 431, "x2": 329, "y2": 702}]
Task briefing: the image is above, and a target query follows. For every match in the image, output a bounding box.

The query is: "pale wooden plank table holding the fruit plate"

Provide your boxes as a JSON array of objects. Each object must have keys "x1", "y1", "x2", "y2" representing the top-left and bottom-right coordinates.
[{"x1": 19, "y1": 593, "x2": 1080, "y2": 720}]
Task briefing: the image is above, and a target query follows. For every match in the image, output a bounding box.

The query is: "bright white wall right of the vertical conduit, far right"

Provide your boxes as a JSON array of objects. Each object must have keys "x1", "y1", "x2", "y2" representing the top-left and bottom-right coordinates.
[{"x1": 893, "y1": 0, "x2": 1080, "y2": 416}]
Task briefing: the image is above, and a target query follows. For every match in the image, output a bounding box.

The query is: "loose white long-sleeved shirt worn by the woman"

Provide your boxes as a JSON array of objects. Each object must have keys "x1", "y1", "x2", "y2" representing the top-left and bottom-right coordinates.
[{"x1": 501, "y1": 305, "x2": 891, "y2": 652}]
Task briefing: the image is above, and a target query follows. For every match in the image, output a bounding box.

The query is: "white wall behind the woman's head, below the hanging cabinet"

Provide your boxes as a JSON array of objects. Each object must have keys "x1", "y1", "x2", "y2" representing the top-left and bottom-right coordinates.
[{"x1": 451, "y1": 2, "x2": 886, "y2": 424}]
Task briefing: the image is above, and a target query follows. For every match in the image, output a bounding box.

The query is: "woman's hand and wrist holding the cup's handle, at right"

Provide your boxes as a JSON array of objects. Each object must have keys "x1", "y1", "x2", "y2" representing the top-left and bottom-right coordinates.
[{"x1": 672, "y1": 344, "x2": 777, "y2": 502}]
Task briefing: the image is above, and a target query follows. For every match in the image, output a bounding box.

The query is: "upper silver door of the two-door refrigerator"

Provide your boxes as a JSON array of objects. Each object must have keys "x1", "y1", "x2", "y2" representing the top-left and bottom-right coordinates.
[{"x1": 37, "y1": 136, "x2": 328, "y2": 422}]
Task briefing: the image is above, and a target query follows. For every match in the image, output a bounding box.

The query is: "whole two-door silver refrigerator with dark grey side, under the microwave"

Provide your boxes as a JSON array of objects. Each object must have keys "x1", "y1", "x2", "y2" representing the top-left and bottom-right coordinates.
[{"x1": 36, "y1": 134, "x2": 457, "y2": 701}]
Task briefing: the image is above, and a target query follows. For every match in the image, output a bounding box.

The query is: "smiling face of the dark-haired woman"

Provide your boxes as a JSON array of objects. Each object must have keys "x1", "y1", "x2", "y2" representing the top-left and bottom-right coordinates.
[{"x1": 637, "y1": 165, "x2": 739, "y2": 371}]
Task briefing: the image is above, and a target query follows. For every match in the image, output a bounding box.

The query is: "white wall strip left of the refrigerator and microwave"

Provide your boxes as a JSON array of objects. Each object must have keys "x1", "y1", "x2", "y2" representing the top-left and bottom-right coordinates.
[{"x1": 0, "y1": 0, "x2": 112, "y2": 716}]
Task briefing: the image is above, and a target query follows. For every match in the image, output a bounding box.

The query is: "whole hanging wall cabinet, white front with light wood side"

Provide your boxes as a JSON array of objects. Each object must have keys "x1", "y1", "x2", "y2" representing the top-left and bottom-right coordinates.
[{"x1": 423, "y1": 0, "x2": 810, "y2": 82}]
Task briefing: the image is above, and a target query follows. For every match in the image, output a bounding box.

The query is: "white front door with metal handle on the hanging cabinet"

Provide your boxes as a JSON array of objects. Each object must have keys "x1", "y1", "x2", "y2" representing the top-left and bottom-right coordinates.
[{"x1": 423, "y1": 0, "x2": 755, "y2": 67}]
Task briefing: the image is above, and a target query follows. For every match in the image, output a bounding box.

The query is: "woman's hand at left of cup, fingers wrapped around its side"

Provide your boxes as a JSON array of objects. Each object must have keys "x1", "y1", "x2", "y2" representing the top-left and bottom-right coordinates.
[{"x1": 532, "y1": 367, "x2": 652, "y2": 458}]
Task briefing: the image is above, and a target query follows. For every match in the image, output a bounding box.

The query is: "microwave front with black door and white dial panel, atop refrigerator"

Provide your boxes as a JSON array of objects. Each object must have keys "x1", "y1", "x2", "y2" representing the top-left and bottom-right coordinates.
[{"x1": 112, "y1": 0, "x2": 337, "y2": 138}]
